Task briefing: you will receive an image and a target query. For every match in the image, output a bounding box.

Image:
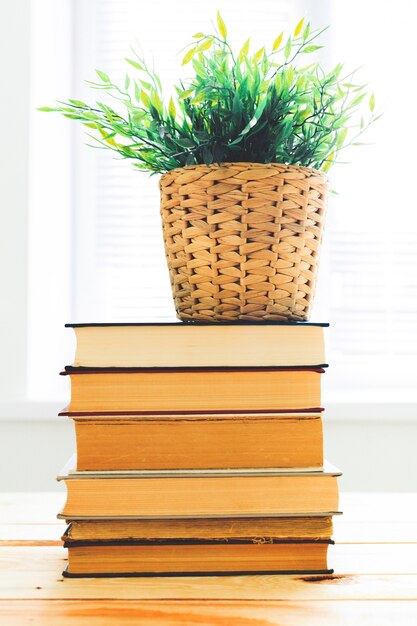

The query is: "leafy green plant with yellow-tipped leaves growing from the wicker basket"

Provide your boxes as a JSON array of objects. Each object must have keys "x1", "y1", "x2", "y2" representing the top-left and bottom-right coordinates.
[{"x1": 41, "y1": 13, "x2": 378, "y2": 173}]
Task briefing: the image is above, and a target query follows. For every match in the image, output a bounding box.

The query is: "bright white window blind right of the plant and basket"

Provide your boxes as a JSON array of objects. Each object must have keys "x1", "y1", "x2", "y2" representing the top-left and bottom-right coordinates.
[{"x1": 321, "y1": 0, "x2": 417, "y2": 394}]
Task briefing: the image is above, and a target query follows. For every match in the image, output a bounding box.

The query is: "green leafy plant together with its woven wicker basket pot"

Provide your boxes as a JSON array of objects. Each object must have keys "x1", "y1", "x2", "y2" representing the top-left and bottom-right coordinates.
[{"x1": 41, "y1": 13, "x2": 377, "y2": 322}]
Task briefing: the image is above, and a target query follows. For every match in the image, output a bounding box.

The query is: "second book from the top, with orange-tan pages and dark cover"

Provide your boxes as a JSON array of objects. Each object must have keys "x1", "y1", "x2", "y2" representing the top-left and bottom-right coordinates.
[{"x1": 61, "y1": 367, "x2": 324, "y2": 415}]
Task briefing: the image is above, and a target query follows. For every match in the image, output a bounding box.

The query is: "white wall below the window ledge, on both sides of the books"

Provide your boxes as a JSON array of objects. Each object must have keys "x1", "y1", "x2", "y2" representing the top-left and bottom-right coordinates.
[{"x1": 0, "y1": 412, "x2": 417, "y2": 491}]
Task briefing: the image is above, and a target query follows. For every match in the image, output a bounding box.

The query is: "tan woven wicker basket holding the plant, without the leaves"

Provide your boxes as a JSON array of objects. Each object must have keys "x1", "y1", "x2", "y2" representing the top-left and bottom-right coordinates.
[{"x1": 160, "y1": 163, "x2": 328, "y2": 322}]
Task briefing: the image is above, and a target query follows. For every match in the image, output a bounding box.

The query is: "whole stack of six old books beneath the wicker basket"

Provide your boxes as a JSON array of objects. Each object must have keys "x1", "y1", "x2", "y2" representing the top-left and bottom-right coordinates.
[{"x1": 58, "y1": 322, "x2": 340, "y2": 576}]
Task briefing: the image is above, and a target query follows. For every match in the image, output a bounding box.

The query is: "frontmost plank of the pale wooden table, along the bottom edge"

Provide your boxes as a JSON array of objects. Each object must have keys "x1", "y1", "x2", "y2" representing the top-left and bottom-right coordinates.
[{"x1": 0, "y1": 600, "x2": 417, "y2": 626}]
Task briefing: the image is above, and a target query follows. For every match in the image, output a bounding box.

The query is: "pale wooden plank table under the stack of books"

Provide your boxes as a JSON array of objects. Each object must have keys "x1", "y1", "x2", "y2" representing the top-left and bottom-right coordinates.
[{"x1": 0, "y1": 493, "x2": 417, "y2": 626}]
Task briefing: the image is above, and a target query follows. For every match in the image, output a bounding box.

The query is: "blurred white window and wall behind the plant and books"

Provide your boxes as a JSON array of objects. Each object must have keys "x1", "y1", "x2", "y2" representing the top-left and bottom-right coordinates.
[{"x1": 0, "y1": 0, "x2": 417, "y2": 491}]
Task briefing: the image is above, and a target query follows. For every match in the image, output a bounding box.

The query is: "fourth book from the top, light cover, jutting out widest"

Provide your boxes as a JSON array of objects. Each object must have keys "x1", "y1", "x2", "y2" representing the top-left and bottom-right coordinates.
[{"x1": 58, "y1": 461, "x2": 340, "y2": 519}]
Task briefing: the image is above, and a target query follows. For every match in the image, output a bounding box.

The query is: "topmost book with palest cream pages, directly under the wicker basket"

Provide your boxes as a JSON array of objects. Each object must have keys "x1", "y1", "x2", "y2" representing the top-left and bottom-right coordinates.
[{"x1": 66, "y1": 322, "x2": 328, "y2": 367}]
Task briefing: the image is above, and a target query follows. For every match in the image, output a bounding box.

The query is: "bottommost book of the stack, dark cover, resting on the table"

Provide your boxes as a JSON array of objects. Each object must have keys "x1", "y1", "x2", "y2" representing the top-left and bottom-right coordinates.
[{"x1": 64, "y1": 540, "x2": 333, "y2": 577}]
